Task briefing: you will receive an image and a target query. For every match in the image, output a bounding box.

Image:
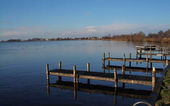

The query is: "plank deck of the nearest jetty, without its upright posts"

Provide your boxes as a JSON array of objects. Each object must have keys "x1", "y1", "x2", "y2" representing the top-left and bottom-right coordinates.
[{"x1": 49, "y1": 69, "x2": 157, "y2": 86}]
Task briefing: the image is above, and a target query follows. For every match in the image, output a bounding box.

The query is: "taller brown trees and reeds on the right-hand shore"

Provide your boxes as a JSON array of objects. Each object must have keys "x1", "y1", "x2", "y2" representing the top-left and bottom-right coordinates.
[{"x1": 102, "y1": 29, "x2": 170, "y2": 43}]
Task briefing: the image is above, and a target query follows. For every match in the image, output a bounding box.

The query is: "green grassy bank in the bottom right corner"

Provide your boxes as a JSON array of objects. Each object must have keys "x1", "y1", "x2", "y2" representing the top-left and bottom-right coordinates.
[{"x1": 155, "y1": 69, "x2": 170, "y2": 106}]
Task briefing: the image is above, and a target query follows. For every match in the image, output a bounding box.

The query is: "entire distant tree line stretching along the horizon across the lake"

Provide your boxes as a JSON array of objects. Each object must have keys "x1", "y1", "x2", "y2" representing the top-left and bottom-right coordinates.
[{"x1": 1, "y1": 29, "x2": 170, "y2": 43}]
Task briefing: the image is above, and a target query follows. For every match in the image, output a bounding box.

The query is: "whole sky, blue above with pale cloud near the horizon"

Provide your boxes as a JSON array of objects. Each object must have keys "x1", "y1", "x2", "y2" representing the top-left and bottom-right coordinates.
[{"x1": 0, "y1": 0, "x2": 170, "y2": 40}]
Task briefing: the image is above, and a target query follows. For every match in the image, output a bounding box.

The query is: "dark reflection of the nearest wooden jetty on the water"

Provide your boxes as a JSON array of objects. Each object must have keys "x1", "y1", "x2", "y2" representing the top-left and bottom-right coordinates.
[{"x1": 47, "y1": 80, "x2": 152, "y2": 100}]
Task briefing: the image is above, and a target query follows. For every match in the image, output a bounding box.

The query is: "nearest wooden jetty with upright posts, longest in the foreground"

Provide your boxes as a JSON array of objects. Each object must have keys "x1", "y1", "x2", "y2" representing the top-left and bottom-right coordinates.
[{"x1": 46, "y1": 62, "x2": 157, "y2": 90}]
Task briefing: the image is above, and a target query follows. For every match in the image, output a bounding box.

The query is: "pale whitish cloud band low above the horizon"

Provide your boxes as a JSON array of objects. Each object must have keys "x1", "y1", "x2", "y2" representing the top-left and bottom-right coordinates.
[{"x1": 0, "y1": 23, "x2": 170, "y2": 38}]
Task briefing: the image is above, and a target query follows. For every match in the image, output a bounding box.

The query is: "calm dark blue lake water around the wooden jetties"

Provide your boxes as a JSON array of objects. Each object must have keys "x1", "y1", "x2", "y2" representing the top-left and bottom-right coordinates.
[{"x1": 0, "y1": 41, "x2": 167, "y2": 106}]
